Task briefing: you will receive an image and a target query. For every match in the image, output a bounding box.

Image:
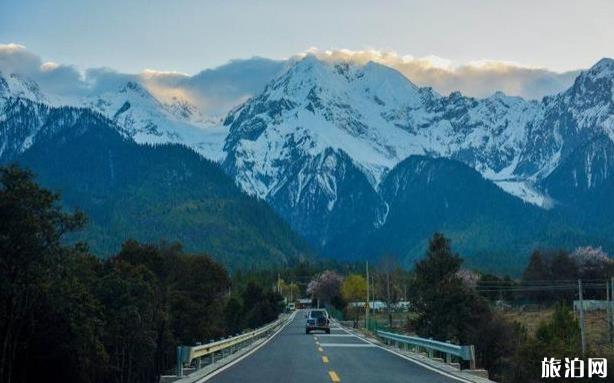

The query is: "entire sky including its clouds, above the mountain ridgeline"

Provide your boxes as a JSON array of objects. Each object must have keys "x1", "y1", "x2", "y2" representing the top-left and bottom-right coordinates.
[{"x1": 0, "y1": 0, "x2": 614, "y2": 103}]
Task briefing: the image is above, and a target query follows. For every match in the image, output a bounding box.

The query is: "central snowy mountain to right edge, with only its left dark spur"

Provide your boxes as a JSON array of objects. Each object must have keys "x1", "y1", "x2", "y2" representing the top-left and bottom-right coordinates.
[{"x1": 223, "y1": 56, "x2": 614, "y2": 262}]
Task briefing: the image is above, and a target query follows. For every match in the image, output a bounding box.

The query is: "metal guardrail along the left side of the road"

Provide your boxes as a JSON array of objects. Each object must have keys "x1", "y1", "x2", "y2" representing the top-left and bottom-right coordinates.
[{"x1": 177, "y1": 315, "x2": 288, "y2": 377}]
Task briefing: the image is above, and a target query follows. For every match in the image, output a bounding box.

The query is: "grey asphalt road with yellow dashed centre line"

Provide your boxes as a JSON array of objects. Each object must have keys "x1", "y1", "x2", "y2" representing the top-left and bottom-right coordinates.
[{"x1": 208, "y1": 311, "x2": 466, "y2": 383}]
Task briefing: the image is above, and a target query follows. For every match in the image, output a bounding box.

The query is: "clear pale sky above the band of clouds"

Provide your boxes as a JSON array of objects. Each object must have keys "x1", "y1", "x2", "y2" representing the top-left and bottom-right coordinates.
[{"x1": 0, "y1": 0, "x2": 614, "y2": 74}]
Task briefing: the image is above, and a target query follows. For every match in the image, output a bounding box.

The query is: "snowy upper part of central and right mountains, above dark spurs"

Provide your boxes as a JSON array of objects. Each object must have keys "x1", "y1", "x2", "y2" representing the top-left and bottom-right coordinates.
[{"x1": 225, "y1": 56, "x2": 614, "y2": 205}]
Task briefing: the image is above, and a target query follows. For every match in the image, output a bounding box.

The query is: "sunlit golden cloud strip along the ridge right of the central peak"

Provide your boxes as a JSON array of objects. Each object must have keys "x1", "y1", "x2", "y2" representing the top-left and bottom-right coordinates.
[{"x1": 305, "y1": 48, "x2": 579, "y2": 99}]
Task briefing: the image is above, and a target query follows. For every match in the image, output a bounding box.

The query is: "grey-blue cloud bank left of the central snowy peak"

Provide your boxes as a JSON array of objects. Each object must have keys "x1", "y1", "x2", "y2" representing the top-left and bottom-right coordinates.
[{"x1": 0, "y1": 44, "x2": 288, "y2": 117}]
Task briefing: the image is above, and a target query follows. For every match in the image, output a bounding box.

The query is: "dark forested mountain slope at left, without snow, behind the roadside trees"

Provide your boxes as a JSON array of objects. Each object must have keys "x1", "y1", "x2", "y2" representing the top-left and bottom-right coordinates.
[{"x1": 5, "y1": 107, "x2": 313, "y2": 269}]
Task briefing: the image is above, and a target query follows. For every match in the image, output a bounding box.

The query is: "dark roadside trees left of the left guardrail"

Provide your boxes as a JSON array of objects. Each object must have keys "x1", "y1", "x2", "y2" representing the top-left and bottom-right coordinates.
[{"x1": 0, "y1": 166, "x2": 282, "y2": 383}]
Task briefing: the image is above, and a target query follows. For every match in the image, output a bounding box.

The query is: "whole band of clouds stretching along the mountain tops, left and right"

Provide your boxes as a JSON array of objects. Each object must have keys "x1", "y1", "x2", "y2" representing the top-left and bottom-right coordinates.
[{"x1": 0, "y1": 44, "x2": 578, "y2": 112}]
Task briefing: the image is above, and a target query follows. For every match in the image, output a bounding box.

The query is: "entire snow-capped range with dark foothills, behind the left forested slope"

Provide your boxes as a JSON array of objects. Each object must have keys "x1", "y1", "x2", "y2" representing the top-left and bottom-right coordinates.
[{"x1": 0, "y1": 56, "x2": 614, "y2": 268}]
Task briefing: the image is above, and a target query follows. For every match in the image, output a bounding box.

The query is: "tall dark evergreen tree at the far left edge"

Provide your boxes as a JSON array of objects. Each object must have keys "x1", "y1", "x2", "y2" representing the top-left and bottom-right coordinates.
[{"x1": 0, "y1": 166, "x2": 85, "y2": 383}]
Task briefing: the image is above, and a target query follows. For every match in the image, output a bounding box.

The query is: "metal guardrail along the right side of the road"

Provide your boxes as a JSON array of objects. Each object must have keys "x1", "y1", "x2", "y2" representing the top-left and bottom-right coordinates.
[{"x1": 376, "y1": 330, "x2": 475, "y2": 370}]
